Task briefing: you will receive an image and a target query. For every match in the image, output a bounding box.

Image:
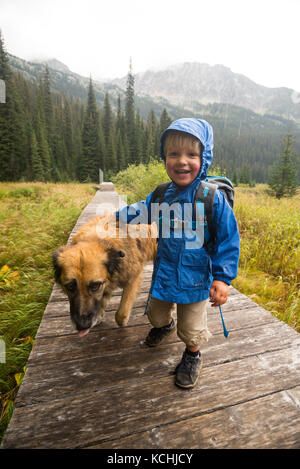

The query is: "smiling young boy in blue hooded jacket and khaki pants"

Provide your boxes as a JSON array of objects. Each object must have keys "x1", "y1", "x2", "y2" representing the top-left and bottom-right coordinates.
[{"x1": 117, "y1": 118, "x2": 239, "y2": 389}]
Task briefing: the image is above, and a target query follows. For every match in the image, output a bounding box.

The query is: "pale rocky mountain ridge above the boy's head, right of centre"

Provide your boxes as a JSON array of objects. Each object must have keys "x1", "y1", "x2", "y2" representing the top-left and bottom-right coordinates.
[{"x1": 112, "y1": 62, "x2": 300, "y2": 120}]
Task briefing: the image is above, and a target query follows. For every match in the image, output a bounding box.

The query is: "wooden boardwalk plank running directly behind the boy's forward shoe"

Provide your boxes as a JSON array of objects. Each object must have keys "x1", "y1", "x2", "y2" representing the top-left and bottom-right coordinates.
[{"x1": 12, "y1": 321, "x2": 300, "y2": 405}]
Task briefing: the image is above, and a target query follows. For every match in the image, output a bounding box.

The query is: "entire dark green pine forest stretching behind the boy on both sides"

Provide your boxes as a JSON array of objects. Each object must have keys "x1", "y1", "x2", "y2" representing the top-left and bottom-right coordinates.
[{"x1": 0, "y1": 30, "x2": 300, "y2": 184}]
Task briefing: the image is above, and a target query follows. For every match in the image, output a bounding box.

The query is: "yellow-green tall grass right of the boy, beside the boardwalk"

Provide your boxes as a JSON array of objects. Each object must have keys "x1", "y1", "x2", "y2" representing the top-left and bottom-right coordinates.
[{"x1": 234, "y1": 185, "x2": 300, "y2": 331}]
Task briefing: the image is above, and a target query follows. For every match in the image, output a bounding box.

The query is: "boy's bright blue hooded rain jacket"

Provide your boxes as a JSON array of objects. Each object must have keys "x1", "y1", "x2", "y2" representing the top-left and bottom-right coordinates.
[{"x1": 117, "y1": 118, "x2": 240, "y2": 304}]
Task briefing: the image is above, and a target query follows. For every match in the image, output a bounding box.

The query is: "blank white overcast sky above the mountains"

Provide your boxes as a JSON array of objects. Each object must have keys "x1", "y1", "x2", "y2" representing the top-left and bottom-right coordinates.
[{"x1": 0, "y1": 0, "x2": 300, "y2": 91}]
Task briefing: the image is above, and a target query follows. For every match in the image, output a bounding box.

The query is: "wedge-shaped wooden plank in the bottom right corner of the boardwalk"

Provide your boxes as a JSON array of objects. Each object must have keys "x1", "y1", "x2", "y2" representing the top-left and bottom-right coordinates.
[{"x1": 90, "y1": 387, "x2": 300, "y2": 449}]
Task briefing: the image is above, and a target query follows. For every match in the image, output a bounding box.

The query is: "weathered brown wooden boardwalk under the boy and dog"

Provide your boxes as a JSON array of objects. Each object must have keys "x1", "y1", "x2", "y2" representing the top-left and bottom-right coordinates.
[{"x1": 2, "y1": 182, "x2": 300, "y2": 449}]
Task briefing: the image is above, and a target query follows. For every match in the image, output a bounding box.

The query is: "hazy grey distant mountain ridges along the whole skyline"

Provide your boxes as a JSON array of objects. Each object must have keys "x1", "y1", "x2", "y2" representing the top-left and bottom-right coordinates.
[{"x1": 10, "y1": 55, "x2": 300, "y2": 121}]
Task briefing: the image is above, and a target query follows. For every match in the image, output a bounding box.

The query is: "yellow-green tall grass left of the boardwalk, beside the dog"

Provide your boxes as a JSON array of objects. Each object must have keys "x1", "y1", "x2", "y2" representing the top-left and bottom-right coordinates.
[{"x1": 0, "y1": 183, "x2": 95, "y2": 439}]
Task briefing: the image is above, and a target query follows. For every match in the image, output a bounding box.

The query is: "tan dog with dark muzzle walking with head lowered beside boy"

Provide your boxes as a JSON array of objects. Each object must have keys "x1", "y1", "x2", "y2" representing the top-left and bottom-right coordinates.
[{"x1": 53, "y1": 216, "x2": 157, "y2": 336}]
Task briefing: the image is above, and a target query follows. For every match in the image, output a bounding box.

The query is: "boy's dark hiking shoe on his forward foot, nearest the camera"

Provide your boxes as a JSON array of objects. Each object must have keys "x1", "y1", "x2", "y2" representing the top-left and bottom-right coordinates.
[{"x1": 175, "y1": 350, "x2": 202, "y2": 389}]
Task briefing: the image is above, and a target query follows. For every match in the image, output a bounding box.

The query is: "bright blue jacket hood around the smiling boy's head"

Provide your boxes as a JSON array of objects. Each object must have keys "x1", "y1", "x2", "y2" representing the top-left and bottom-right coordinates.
[{"x1": 160, "y1": 117, "x2": 214, "y2": 179}]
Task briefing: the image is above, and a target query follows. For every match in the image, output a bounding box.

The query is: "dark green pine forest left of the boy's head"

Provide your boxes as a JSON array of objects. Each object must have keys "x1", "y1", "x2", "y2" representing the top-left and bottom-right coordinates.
[{"x1": 0, "y1": 32, "x2": 170, "y2": 182}]
